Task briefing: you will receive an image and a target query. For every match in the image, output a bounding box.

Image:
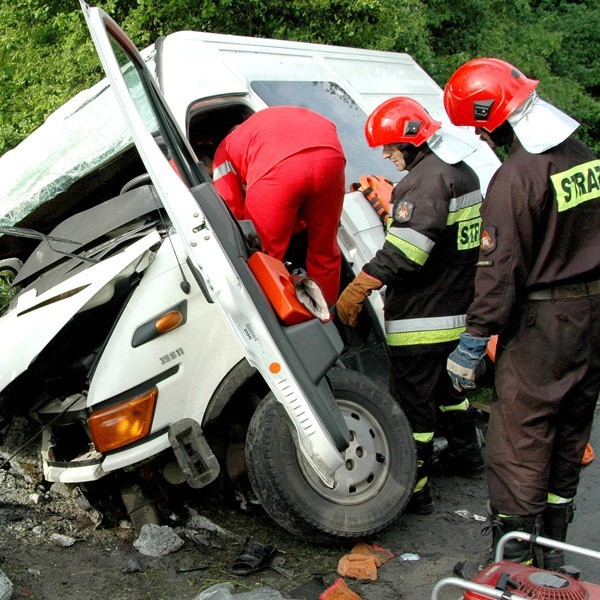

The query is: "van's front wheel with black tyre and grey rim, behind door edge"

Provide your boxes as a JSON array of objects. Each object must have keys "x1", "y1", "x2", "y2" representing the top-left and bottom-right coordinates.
[{"x1": 246, "y1": 369, "x2": 416, "y2": 543}]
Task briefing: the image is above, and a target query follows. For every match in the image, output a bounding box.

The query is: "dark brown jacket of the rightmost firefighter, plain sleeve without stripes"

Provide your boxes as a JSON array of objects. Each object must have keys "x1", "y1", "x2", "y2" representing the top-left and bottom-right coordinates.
[{"x1": 467, "y1": 137, "x2": 600, "y2": 337}]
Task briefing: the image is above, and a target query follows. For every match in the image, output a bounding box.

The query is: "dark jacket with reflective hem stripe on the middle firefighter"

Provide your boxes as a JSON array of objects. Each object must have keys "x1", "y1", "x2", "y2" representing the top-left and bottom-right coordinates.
[{"x1": 363, "y1": 151, "x2": 481, "y2": 354}]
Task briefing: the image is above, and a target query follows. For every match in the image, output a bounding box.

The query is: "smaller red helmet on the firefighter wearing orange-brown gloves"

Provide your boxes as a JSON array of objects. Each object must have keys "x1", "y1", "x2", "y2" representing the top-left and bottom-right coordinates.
[{"x1": 365, "y1": 96, "x2": 442, "y2": 148}]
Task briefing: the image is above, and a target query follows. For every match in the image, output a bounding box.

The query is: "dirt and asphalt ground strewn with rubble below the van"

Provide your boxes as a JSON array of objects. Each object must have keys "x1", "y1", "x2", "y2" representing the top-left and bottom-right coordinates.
[{"x1": 0, "y1": 404, "x2": 600, "y2": 600}]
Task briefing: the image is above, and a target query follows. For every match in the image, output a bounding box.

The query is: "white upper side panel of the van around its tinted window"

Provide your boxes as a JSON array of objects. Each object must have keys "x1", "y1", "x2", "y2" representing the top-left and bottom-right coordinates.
[{"x1": 156, "y1": 31, "x2": 499, "y2": 192}]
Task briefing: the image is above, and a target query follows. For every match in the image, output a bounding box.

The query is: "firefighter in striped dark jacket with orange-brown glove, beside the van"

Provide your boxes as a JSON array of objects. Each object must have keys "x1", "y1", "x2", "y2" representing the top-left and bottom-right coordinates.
[{"x1": 336, "y1": 97, "x2": 483, "y2": 514}]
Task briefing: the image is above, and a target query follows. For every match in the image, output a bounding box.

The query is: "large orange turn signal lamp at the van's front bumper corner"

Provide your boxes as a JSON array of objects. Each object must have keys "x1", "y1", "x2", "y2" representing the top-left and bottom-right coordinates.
[{"x1": 88, "y1": 388, "x2": 158, "y2": 452}]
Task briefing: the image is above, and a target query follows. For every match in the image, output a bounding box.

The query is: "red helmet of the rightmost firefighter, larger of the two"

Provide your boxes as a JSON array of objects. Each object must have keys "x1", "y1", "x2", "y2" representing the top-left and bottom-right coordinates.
[{"x1": 444, "y1": 58, "x2": 539, "y2": 131}]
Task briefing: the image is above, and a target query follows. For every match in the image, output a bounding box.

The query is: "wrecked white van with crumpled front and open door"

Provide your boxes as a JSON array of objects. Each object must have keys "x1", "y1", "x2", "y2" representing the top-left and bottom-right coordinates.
[{"x1": 0, "y1": 5, "x2": 497, "y2": 541}]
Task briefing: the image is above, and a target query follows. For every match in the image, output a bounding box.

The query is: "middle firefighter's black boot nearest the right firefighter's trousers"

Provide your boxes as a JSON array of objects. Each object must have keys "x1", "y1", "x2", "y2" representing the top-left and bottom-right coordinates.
[{"x1": 439, "y1": 408, "x2": 485, "y2": 476}]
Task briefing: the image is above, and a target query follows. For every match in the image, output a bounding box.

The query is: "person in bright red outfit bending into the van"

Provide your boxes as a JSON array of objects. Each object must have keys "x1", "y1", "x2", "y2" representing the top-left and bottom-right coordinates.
[{"x1": 213, "y1": 106, "x2": 346, "y2": 304}]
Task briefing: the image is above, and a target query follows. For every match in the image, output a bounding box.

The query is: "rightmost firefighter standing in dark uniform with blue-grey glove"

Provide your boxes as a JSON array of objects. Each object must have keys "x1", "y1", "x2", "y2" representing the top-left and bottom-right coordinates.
[{"x1": 444, "y1": 58, "x2": 600, "y2": 570}]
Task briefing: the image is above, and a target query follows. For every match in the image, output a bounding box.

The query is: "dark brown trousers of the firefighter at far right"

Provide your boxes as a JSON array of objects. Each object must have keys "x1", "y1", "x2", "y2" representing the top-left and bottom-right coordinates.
[{"x1": 486, "y1": 295, "x2": 600, "y2": 516}]
